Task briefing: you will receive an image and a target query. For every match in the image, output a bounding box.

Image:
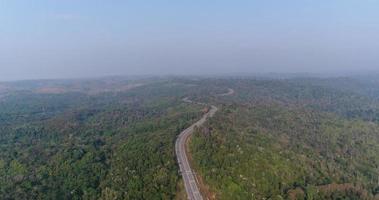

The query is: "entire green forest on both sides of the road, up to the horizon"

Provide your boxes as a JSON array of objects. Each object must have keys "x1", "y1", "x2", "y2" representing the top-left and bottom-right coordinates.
[{"x1": 0, "y1": 77, "x2": 379, "y2": 200}]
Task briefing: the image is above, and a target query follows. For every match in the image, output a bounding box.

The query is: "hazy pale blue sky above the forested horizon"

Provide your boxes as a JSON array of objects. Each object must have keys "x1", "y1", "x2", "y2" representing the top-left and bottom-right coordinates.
[{"x1": 0, "y1": 0, "x2": 379, "y2": 81}]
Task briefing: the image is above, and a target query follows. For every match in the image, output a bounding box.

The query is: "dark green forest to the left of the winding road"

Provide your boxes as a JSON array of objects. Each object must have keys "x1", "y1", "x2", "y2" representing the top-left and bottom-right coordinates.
[{"x1": 0, "y1": 79, "x2": 205, "y2": 199}]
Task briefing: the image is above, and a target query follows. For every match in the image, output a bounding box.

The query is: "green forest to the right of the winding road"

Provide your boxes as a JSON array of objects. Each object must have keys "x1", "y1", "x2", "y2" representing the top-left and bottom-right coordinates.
[{"x1": 191, "y1": 79, "x2": 379, "y2": 199}]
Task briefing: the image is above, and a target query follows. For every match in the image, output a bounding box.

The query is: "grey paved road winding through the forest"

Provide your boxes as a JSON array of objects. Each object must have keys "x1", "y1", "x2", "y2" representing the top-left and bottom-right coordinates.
[{"x1": 175, "y1": 89, "x2": 234, "y2": 200}]
